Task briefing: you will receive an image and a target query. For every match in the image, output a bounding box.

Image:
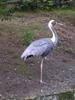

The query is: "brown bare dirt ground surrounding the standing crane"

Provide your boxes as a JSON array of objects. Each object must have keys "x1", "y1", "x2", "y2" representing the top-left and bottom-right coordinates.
[{"x1": 0, "y1": 12, "x2": 75, "y2": 100}]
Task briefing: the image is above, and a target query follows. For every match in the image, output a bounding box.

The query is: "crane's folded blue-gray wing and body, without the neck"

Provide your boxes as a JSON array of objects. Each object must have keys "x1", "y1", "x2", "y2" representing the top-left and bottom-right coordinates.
[{"x1": 21, "y1": 38, "x2": 54, "y2": 59}]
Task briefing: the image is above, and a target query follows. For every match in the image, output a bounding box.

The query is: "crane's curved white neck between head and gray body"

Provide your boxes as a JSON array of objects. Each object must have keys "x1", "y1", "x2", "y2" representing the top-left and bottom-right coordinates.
[{"x1": 49, "y1": 24, "x2": 58, "y2": 46}]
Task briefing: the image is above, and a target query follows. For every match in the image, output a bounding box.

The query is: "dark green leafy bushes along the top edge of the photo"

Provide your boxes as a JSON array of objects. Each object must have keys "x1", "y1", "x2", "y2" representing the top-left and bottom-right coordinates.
[{"x1": 0, "y1": 0, "x2": 75, "y2": 14}]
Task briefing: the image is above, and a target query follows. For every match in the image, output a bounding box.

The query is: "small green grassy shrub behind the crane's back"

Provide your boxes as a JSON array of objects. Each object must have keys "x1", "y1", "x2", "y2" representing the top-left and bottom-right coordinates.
[{"x1": 23, "y1": 28, "x2": 34, "y2": 46}]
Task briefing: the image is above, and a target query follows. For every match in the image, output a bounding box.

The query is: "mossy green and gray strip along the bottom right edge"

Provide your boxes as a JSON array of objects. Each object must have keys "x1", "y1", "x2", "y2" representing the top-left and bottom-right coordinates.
[{"x1": 25, "y1": 91, "x2": 75, "y2": 100}]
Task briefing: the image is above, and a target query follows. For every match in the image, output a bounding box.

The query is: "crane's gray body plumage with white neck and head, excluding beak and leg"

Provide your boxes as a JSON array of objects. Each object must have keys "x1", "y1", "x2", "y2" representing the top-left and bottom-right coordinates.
[{"x1": 21, "y1": 20, "x2": 58, "y2": 60}]
